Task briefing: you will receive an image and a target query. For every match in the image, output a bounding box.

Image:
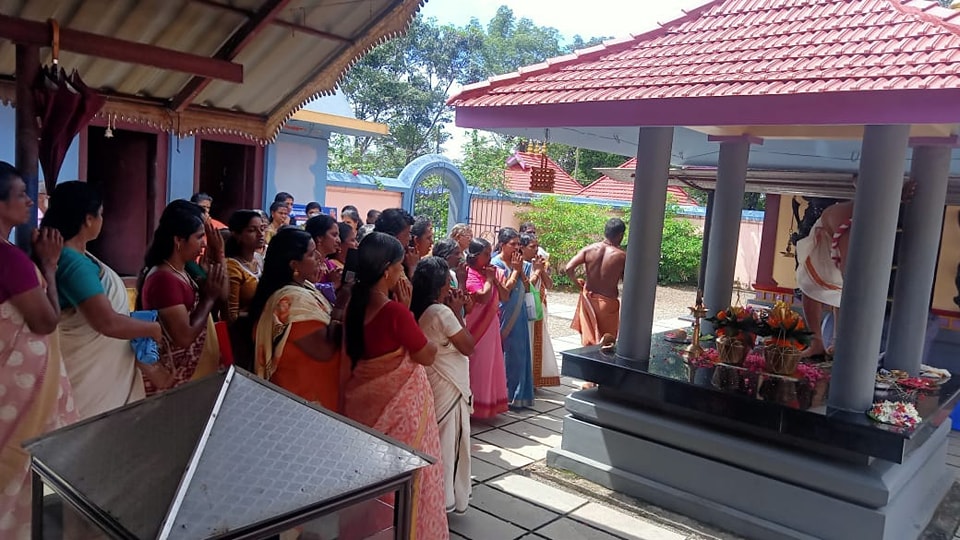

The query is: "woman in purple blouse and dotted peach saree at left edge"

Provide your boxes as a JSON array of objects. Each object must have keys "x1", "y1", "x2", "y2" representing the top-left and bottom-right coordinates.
[{"x1": 0, "y1": 162, "x2": 77, "y2": 540}]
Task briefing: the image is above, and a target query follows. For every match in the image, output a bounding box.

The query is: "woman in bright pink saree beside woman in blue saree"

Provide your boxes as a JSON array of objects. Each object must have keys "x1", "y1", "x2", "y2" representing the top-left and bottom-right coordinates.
[{"x1": 466, "y1": 238, "x2": 507, "y2": 418}]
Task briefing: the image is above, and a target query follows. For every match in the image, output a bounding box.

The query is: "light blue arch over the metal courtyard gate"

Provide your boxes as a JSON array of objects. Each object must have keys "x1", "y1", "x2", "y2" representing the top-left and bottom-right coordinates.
[{"x1": 397, "y1": 154, "x2": 470, "y2": 231}]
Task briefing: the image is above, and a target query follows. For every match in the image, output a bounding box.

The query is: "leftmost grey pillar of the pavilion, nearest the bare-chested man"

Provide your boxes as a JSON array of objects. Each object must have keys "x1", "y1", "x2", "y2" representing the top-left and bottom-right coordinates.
[{"x1": 617, "y1": 127, "x2": 673, "y2": 360}]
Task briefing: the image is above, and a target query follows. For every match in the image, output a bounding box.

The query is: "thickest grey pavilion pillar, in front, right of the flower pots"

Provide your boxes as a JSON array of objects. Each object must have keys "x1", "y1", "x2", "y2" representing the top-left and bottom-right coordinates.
[{"x1": 827, "y1": 125, "x2": 912, "y2": 413}]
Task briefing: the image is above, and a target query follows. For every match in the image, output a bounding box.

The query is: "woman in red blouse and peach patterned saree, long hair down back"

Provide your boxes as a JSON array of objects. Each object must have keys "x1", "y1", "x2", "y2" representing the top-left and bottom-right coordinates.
[{"x1": 340, "y1": 232, "x2": 450, "y2": 540}]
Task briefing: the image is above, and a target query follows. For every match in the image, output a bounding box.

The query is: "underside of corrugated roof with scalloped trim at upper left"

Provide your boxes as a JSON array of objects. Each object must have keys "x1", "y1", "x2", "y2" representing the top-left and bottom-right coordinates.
[{"x1": 0, "y1": 0, "x2": 422, "y2": 141}]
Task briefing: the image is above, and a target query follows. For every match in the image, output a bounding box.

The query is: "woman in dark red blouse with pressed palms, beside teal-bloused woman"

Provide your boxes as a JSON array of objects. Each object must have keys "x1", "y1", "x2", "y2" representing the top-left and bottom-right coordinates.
[{"x1": 137, "y1": 200, "x2": 226, "y2": 396}]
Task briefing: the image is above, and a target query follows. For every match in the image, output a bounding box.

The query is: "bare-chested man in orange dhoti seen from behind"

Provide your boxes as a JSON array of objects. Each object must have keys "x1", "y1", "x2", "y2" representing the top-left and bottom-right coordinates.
[{"x1": 564, "y1": 218, "x2": 626, "y2": 346}]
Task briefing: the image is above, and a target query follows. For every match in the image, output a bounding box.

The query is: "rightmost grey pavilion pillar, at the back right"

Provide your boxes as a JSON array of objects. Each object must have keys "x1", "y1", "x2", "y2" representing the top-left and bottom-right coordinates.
[{"x1": 883, "y1": 146, "x2": 953, "y2": 375}]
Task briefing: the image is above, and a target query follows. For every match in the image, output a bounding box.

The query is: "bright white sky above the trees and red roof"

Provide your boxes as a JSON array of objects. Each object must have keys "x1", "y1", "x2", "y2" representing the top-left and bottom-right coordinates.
[{"x1": 420, "y1": 0, "x2": 709, "y2": 159}]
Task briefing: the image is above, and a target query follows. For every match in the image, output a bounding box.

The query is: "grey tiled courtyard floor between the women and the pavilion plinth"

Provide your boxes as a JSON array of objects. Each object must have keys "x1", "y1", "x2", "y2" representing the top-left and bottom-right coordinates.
[{"x1": 450, "y1": 298, "x2": 960, "y2": 540}]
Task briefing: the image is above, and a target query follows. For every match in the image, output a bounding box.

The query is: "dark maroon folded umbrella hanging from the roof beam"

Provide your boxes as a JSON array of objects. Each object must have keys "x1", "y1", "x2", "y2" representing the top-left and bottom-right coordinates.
[{"x1": 33, "y1": 20, "x2": 106, "y2": 193}]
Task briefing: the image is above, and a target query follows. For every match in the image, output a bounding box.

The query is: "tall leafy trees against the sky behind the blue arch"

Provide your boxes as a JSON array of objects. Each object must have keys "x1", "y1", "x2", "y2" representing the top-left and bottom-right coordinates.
[{"x1": 338, "y1": 6, "x2": 623, "y2": 184}]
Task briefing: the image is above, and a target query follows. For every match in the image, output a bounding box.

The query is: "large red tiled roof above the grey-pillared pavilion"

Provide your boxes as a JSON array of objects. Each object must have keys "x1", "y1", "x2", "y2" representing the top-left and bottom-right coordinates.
[{"x1": 450, "y1": 0, "x2": 960, "y2": 107}]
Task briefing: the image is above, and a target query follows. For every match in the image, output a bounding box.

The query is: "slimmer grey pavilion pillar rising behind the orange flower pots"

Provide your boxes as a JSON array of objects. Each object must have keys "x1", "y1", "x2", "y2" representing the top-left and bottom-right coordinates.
[{"x1": 703, "y1": 137, "x2": 750, "y2": 333}]
